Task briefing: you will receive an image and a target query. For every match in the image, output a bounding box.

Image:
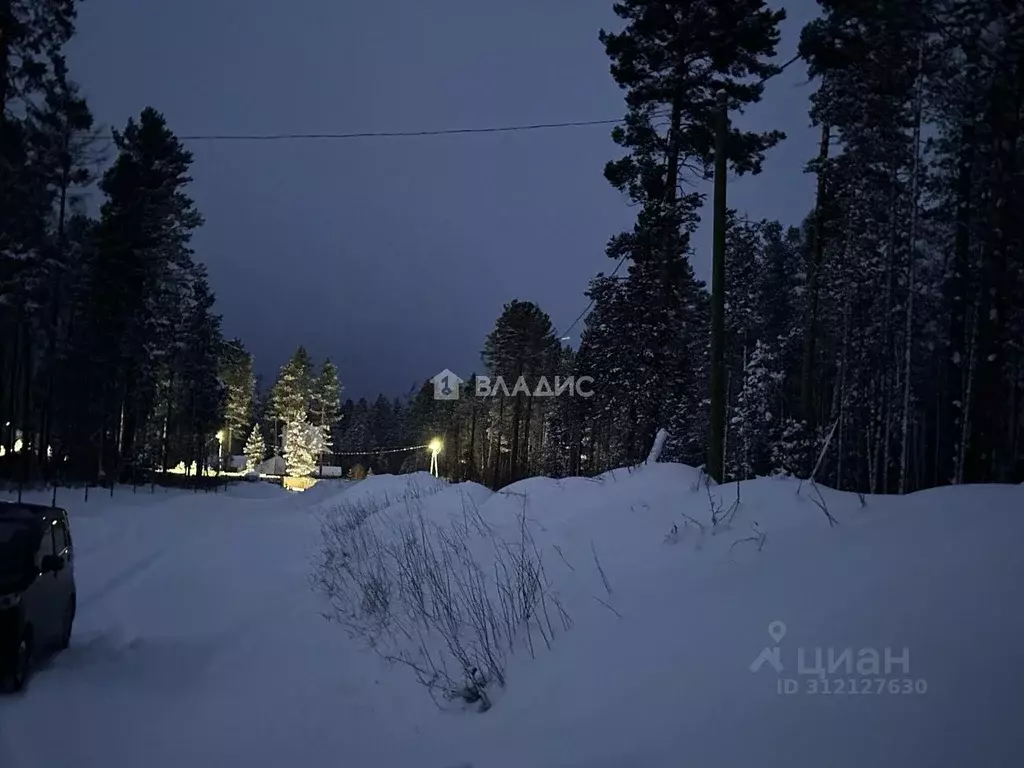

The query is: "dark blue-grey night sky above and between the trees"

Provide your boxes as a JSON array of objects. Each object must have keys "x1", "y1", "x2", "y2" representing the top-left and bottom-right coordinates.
[{"x1": 71, "y1": 0, "x2": 817, "y2": 397}]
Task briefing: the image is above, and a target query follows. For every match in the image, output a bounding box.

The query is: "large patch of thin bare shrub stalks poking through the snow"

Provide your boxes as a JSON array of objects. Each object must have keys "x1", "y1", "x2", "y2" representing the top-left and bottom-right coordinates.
[{"x1": 311, "y1": 484, "x2": 573, "y2": 711}]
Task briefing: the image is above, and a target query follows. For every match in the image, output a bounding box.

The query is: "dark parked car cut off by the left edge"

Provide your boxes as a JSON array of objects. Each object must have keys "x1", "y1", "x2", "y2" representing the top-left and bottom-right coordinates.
[{"x1": 0, "y1": 502, "x2": 77, "y2": 691}]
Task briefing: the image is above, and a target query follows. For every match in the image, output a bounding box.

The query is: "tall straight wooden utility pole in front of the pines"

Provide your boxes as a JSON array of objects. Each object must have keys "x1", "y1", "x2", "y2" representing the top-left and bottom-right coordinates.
[{"x1": 708, "y1": 89, "x2": 729, "y2": 482}]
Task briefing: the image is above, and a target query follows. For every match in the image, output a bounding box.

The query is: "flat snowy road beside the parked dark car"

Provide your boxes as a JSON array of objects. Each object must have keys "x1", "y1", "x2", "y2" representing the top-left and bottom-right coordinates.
[{"x1": 0, "y1": 485, "x2": 452, "y2": 768}]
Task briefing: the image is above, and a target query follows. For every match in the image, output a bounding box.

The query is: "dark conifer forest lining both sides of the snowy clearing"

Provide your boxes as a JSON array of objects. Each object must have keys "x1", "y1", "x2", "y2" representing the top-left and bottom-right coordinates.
[{"x1": 0, "y1": 0, "x2": 1024, "y2": 493}]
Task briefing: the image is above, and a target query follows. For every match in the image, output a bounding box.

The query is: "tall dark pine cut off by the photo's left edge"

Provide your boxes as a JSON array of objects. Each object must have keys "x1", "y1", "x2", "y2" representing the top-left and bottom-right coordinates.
[{"x1": 0, "y1": 0, "x2": 92, "y2": 480}]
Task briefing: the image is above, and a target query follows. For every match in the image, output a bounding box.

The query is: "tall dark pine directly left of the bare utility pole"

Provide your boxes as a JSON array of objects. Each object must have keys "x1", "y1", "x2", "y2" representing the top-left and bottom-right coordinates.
[{"x1": 600, "y1": 0, "x2": 785, "y2": 475}]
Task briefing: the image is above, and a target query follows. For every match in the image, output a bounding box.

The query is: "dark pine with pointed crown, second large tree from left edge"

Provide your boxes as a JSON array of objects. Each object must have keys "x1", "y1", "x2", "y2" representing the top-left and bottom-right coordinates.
[{"x1": 76, "y1": 108, "x2": 204, "y2": 481}]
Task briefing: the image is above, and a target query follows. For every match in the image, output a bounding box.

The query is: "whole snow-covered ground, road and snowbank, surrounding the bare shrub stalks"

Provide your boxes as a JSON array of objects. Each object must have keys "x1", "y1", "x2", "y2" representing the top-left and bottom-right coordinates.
[{"x1": 0, "y1": 464, "x2": 1024, "y2": 768}]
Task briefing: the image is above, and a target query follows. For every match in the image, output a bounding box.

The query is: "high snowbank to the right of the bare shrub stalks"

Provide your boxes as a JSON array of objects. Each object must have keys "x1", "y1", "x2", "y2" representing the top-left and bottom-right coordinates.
[{"x1": 311, "y1": 464, "x2": 1024, "y2": 768}]
